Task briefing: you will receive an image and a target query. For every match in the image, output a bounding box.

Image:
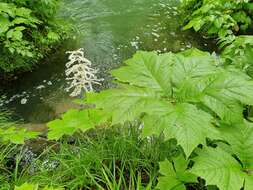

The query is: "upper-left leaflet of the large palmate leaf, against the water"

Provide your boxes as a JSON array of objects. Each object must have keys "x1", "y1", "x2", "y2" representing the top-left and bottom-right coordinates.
[{"x1": 112, "y1": 51, "x2": 173, "y2": 94}]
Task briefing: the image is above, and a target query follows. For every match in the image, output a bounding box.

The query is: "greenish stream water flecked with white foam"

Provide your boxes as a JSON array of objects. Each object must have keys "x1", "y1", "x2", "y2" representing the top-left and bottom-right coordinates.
[{"x1": 0, "y1": 0, "x2": 213, "y2": 128}]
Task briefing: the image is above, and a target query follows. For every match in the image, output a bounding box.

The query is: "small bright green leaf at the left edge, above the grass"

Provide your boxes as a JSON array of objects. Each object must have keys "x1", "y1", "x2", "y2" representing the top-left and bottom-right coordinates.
[{"x1": 0, "y1": 127, "x2": 39, "y2": 144}]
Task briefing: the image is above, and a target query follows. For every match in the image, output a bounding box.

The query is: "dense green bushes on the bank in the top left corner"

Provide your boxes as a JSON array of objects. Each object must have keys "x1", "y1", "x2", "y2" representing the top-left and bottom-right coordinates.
[{"x1": 0, "y1": 0, "x2": 68, "y2": 73}]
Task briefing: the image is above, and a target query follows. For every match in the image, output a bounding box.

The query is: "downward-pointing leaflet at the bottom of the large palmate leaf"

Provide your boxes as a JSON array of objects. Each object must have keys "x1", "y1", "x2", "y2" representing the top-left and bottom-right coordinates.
[{"x1": 168, "y1": 103, "x2": 215, "y2": 157}]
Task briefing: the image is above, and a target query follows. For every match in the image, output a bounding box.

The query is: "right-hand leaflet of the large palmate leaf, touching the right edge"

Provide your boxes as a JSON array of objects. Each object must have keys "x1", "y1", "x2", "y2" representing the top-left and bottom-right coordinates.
[{"x1": 173, "y1": 60, "x2": 253, "y2": 123}]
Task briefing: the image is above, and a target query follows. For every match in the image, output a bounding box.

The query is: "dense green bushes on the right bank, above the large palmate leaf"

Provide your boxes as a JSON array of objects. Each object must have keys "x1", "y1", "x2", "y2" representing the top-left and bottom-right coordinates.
[{"x1": 182, "y1": 0, "x2": 253, "y2": 76}]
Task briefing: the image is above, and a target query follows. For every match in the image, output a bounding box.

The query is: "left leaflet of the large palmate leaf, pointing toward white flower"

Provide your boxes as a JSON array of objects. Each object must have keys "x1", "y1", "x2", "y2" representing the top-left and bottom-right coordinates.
[{"x1": 87, "y1": 85, "x2": 167, "y2": 124}]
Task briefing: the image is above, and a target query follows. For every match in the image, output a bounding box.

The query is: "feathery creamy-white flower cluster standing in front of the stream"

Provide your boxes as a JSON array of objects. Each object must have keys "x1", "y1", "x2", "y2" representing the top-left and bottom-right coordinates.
[{"x1": 65, "y1": 48, "x2": 104, "y2": 97}]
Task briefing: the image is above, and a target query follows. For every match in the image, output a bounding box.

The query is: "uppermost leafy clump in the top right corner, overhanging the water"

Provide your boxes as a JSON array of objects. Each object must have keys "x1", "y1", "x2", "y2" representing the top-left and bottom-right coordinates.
[{"x1": 184, "y1": 0, "x2": 252, "y2": 38}]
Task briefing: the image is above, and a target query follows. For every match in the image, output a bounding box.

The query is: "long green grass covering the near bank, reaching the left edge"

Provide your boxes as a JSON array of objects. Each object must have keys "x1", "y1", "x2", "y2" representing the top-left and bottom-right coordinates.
[{"x1": 0, "y1": 113, "x2": 211, "y2": 190}]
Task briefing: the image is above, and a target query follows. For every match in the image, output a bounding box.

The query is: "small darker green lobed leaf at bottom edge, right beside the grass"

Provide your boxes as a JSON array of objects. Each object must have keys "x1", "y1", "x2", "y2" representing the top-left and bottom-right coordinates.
[{"x1": 157, "y1": 156, "x2": 197, "y2": 190}]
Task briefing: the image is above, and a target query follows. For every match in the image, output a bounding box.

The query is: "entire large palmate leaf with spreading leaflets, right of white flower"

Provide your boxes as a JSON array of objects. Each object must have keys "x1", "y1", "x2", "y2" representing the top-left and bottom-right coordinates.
[{"x1": 87, "y1": 49, "x2": 253, "y2": 157}]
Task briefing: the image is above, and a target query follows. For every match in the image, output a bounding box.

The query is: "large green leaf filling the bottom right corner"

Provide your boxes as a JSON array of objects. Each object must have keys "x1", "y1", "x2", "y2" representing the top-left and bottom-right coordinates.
[{"x1": 192, "y1": 121, "x2": 253, "y2": 190}]
